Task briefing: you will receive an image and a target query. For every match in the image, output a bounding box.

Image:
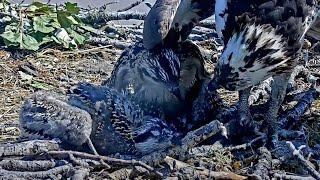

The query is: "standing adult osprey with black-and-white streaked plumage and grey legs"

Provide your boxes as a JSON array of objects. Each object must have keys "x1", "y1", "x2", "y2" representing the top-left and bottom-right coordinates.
[{"x1": 209, "y1": 0, "x2": 317, "y2": 139}]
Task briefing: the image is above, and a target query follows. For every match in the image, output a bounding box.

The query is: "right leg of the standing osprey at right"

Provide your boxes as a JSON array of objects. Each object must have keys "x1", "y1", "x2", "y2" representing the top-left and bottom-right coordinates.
[{"x1": 265, "y1": 74, "x2": 290, "y2": 143}]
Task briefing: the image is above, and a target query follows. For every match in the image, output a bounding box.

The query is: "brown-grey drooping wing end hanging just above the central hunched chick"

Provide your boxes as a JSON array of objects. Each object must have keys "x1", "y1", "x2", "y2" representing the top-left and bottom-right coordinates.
[{"x1": 143, "y1": 0, "x2": 215, "y2": 49}]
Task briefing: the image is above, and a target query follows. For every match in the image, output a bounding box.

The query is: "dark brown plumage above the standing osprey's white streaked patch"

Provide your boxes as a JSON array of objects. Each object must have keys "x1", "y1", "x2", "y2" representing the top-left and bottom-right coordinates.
[{"x1": 222, "y1": 0, "x2": 317, "y2": 46}]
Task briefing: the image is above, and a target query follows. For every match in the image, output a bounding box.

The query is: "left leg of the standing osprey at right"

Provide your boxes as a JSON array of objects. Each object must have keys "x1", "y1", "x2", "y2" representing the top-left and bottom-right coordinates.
[{"x1": 238, "y1": 87, "x2": 251, "y2": 126}]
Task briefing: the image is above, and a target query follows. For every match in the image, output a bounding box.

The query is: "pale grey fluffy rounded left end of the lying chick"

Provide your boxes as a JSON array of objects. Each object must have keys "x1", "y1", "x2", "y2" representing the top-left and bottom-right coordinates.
[{"x1": 20, "y1": 92, "x2": 92, "y2": 146}]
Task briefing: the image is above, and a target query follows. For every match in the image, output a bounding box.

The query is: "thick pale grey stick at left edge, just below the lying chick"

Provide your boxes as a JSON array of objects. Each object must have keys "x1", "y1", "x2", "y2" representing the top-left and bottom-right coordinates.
[{"x1": 0, "y1": 140, "x2": 59, "y2": 157}]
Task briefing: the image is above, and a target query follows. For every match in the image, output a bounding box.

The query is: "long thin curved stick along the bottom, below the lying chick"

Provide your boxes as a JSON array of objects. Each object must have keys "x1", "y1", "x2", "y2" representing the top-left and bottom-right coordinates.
[{"x1": 47, "y1": 151, "x2": 162, "y2": 176}]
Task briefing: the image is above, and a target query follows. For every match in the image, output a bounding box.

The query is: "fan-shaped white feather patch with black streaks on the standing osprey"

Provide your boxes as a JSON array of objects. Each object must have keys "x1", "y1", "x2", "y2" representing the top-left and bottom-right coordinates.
[{"x1": 215, "y1": 23, "x2": 290, "y2": 91}]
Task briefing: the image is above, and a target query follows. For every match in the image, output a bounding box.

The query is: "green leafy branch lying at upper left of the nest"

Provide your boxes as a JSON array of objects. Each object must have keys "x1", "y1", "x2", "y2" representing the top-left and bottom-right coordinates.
[{"x1": 0, "y1": 0, "x2": 88, "y2": 51}]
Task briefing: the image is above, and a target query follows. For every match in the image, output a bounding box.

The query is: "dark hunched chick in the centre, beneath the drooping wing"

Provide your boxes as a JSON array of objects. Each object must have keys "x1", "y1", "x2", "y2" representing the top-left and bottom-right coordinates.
[{"x1": 103, "y1": 41, "x2": 215, "y2": 131}]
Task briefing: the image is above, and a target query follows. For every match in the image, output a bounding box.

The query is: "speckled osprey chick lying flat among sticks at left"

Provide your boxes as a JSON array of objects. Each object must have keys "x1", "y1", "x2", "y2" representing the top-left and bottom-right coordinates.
[{"x1": 20, "y1": 83, "x2": 179, "y2": 155}]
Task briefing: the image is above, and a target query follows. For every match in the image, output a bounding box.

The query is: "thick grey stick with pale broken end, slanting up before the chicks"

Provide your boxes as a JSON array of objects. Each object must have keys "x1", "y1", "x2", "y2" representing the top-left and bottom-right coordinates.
[{"x1": 141, "y1": 120, "x2": 227, "y2": 165}]
